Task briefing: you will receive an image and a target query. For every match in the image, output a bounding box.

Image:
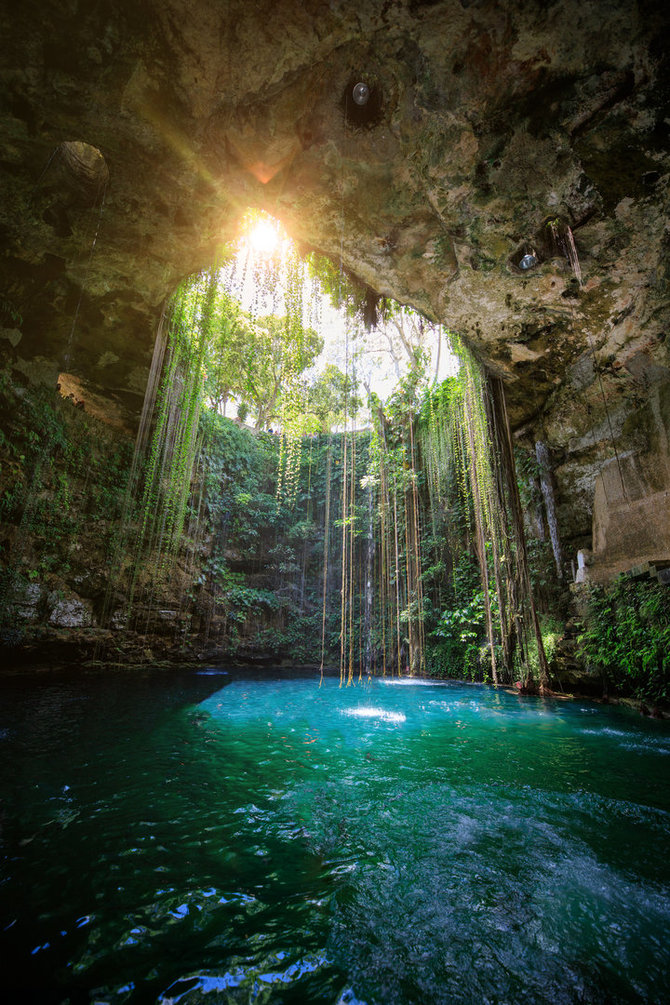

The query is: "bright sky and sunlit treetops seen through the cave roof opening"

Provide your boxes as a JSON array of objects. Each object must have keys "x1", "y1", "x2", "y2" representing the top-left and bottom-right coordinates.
[{"x1": 187, "y1": 210, "x2": 458, "y2": 435}]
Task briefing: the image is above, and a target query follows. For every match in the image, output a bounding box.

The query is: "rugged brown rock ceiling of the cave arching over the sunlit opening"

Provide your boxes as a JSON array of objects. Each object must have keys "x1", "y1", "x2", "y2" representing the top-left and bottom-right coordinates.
[{"x1": 0, "y1": 0, "x2": 670, "y2": 578}]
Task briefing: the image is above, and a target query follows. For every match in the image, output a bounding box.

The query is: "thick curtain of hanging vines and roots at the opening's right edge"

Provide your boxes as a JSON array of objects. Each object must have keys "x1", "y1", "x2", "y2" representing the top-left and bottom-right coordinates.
[{"x1": 418, "y1": 335, "x2": 546, "y2": 683}]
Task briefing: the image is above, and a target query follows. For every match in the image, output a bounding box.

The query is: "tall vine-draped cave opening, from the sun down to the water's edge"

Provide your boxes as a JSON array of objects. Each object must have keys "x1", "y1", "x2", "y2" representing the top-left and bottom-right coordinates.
[{"x1": 100, "y1": 211, "x2": 562, "y2": 686}]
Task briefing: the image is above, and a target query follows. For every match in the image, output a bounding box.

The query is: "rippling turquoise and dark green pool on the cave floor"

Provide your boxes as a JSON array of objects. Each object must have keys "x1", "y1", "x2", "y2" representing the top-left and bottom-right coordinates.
[{"x1": 0, "y1": 672, "x2": 670, "y2": 1005}]
